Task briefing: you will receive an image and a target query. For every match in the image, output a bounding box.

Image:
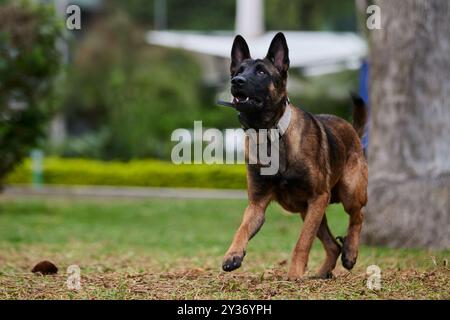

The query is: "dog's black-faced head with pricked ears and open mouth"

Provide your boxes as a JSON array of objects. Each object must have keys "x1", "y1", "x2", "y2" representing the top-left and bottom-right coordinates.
[{"x1": 230, "y1": 32, "x2": 289, "y2": 129}]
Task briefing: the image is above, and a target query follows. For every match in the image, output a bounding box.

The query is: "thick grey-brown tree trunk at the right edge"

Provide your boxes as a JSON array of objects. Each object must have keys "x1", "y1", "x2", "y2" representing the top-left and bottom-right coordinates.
[{"x1": 362, "y1": 0, "x2": 450, "y2": 249}]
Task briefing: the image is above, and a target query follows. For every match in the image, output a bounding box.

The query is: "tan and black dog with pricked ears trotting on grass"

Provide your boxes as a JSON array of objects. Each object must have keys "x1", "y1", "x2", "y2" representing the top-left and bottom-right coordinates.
[{"x1": 222, "y1": 32, "x2": 368, "y2": 280}]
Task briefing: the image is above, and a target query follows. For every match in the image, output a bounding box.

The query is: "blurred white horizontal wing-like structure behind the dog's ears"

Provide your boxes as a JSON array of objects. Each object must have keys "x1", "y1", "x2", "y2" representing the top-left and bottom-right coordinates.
[{"x1": 147, "y1": 31, "x2": 367, "y2": 76}]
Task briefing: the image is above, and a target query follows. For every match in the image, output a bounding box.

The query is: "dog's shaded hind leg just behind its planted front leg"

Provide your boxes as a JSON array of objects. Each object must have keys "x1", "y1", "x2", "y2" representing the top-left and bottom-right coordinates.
[{"x1": 316, "y1": 216, "x2": 341, "y2": 279}]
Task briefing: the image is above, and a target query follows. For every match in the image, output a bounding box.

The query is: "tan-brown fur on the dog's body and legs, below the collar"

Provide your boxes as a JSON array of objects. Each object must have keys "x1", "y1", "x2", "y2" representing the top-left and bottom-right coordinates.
[{"x1": 224, "y1": 106, "x2": 367, "y2": 280}]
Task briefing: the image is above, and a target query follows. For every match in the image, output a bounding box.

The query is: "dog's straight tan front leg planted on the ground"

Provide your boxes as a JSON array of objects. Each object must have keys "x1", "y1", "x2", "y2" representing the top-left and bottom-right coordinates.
[{"x1": 288, "y1": 193, "x2": 330, "y2": 280}]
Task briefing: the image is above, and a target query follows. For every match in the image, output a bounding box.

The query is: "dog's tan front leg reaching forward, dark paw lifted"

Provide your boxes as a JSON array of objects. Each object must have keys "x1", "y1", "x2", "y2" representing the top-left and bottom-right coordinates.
[{"x1": 222, "y1": 201, "x2": 269, "y2": 271}]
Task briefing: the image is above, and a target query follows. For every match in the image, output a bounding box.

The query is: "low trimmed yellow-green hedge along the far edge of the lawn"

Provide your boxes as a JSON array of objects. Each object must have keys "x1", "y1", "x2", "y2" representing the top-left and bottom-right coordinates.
[{"x1": 6, "y1": 158, "x2": 246, "y2": 189}]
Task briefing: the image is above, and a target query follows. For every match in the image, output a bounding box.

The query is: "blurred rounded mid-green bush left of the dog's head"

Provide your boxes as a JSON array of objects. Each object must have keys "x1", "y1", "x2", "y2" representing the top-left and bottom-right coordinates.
[{"x1": 105, "y1": 48, "x2": 201, "y2": 159}]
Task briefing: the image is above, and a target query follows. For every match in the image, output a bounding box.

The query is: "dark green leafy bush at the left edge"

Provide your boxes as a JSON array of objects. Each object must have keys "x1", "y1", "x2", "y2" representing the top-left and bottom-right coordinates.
[{"x1": 0, "y1": 1, "x2": 61, "y2": 184}]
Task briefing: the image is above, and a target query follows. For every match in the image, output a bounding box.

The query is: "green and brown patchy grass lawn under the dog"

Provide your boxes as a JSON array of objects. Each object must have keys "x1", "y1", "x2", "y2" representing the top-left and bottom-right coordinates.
[{"x1": 0, "y1": 197, "x2": 450, "y2": 299}]
